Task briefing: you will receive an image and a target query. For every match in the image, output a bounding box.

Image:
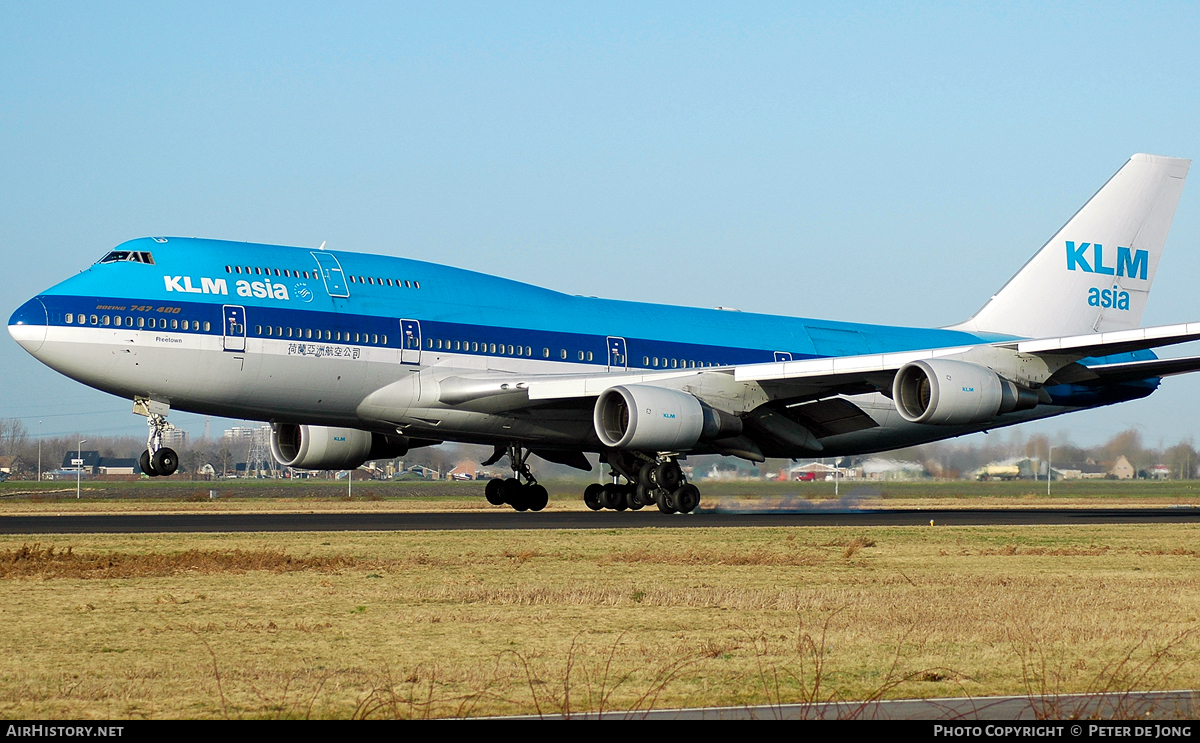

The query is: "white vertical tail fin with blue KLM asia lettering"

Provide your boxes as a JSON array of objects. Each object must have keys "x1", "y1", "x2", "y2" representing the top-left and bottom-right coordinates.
[{"x1": 953, "y1": 155, "x2": 1192, "y2": 337}]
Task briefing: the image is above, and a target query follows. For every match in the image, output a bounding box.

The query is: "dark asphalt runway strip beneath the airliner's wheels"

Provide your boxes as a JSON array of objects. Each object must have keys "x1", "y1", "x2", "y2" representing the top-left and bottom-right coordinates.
[{"x1": 0, "y1": 507, "x2": 1200, "y2": 534}]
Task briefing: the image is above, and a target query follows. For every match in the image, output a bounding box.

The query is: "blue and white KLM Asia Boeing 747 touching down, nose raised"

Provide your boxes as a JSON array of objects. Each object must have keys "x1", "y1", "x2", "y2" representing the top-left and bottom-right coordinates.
[{"x1": 8, "y1": 155, "x2": 1200, "y2": 513}]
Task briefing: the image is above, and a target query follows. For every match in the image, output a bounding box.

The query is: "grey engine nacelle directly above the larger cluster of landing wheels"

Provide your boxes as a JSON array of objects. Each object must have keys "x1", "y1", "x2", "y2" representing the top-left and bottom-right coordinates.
[{"x1": 593, "y1": 384, "x2": 742, "y2": 451}]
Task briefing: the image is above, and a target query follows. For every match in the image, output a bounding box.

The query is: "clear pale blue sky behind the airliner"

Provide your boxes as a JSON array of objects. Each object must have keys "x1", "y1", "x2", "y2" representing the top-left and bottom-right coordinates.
[{"x1": 0, "y1": 0, "x2": 1200, "y2": 444}]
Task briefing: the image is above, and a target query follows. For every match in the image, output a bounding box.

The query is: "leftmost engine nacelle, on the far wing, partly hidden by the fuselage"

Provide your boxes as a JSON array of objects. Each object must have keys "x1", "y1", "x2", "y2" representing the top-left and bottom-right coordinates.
[{"x1": 271, "y1": 424, "x2": 409, "y2": 469}]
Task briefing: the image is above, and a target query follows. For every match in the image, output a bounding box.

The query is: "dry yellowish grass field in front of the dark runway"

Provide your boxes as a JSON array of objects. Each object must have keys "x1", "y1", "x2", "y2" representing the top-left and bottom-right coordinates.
[{"x1": 0, "y1": 518, "x2": 1200, "y2": 718}]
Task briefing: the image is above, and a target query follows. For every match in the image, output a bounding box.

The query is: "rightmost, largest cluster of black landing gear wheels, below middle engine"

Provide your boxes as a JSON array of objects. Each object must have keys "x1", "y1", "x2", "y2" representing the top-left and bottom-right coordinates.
[{"x1": 583, "y1": 451, "x2": 700, "y2": 514}]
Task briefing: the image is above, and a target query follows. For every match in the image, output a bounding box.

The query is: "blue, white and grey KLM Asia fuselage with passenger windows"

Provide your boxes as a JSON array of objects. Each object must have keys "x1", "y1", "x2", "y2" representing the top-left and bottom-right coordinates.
[{"x1": 10, "y1": 238, "x2": 1157, "y2": 454}]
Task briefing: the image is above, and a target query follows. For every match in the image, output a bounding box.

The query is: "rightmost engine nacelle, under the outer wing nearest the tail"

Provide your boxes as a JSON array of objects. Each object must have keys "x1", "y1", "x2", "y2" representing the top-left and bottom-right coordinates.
[{"x1": 892, "y1": 359, "x2": 1038, "y2": 426}]
